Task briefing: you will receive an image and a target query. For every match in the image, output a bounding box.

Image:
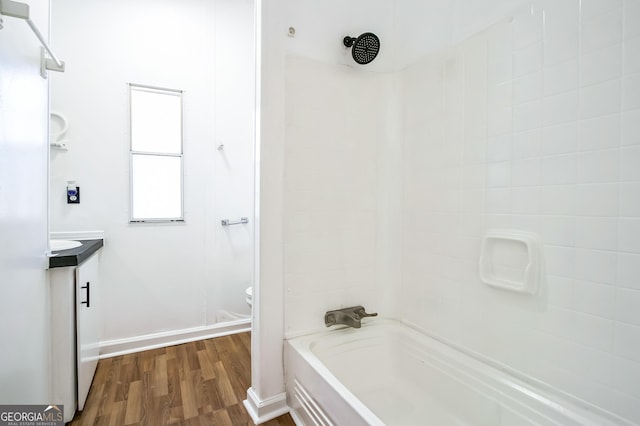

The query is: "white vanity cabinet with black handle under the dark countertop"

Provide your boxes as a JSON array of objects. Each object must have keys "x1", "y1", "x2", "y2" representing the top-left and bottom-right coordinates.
[{"x1": 49, "y1": 251, "x2": 102, "y2": 422}]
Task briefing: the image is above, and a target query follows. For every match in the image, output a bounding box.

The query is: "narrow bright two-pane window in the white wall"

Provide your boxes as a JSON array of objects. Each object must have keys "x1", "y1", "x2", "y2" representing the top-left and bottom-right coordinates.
[{"x1": 129, "y1": 84, "x2": 184, "y2": 222}]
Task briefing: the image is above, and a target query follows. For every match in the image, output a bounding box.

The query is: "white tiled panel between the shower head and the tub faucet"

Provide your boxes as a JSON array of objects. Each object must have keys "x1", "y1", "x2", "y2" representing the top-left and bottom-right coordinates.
[{"x1": 283, "y1": 56, "x2": 394, "y2": 336}]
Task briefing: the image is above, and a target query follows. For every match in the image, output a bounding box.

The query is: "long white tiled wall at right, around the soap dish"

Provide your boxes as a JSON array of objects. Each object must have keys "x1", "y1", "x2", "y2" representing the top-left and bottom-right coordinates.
[{"x1": 399, "y1": 0, "x2": 640, "y2": 422}]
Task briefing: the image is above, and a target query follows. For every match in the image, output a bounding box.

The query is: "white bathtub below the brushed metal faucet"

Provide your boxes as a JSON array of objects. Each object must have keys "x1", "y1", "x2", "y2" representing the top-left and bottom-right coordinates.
[{"x1": 284, "y1": 318, "x2": 631, "y2": 426}]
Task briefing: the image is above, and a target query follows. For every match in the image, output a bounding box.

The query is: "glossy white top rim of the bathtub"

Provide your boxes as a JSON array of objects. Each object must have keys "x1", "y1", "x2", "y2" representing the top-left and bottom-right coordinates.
[{"x1": 285, "y1": 317, "x2": 635, "y2": 426}]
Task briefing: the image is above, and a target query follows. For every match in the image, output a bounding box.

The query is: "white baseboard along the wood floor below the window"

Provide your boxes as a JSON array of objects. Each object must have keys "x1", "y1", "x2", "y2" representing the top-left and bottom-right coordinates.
[{"x1": 100, "y1": 318, "x2": 251, "y2": 359}]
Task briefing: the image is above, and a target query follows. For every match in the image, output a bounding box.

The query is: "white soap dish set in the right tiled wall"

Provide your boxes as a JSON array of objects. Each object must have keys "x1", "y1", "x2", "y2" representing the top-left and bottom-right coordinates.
[{"x1": 480, "y1": 229, "x2": 542, "y2": 294}]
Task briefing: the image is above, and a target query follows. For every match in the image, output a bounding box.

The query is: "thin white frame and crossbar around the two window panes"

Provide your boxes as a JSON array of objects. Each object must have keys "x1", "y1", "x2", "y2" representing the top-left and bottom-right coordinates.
[{"x1": 128, "y1": 83, "x2": 184, "y2": 223}]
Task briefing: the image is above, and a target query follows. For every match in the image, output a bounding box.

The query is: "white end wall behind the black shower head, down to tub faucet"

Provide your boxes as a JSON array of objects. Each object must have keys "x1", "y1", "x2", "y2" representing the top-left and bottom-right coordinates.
[{"x1": 279, "y1": 1, "x2": 401, "y2": 335}]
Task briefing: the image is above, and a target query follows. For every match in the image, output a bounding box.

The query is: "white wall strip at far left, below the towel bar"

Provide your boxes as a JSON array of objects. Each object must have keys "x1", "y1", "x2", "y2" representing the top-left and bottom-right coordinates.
[{"x1": 0, "y1": 0, "x2": 50, "y2": 404}]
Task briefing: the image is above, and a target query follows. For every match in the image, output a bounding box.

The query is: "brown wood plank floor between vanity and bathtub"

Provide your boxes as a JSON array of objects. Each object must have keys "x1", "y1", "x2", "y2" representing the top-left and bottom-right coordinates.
[{"x1": 70, "y1": 333, "x2": 295, "y2": 426}]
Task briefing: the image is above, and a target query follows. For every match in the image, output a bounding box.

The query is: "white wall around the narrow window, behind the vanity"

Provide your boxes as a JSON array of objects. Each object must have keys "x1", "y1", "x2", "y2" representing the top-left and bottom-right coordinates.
[{"x1": 51, "y1": 0, "x2": 255, "y2": 341}]
